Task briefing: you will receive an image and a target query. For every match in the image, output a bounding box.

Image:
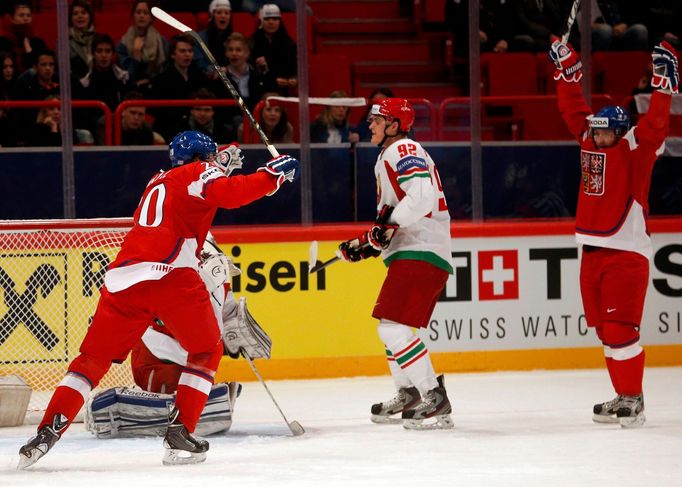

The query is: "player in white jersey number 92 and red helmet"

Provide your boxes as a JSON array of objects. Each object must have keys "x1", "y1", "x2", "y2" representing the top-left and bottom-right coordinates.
[{"x1": 339, "y1": 98, "x2": 453, "y2": 429}]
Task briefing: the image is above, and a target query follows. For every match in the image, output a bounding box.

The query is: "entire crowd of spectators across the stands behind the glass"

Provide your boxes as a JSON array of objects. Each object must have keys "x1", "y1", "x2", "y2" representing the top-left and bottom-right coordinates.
[{"x1": 0, "y1": 0, "x2": 682, "y2": 147}]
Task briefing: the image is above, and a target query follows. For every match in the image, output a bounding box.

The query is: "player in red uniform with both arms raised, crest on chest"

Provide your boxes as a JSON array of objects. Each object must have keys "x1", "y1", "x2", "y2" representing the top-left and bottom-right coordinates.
[{"x1": 549, "y1": 41, "x2": 679, "y2": 428}]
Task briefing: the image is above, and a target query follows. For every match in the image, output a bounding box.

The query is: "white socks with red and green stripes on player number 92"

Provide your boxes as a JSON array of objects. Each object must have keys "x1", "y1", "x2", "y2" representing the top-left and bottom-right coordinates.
[{"x1": 379, "y1": 319, "x2": 438, "y2": 396}]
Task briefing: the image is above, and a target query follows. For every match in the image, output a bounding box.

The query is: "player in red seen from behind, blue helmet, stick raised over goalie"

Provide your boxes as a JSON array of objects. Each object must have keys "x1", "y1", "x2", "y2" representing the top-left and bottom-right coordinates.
[{"x1": 19, "y1": 131, "x2": 299, "y2": 468}]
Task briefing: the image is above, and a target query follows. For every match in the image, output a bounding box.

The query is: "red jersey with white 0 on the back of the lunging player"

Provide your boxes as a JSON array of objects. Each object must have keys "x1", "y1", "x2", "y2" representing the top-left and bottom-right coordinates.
[{"x1": 104, "y1": 162, "x2": 277, "y2": 292}]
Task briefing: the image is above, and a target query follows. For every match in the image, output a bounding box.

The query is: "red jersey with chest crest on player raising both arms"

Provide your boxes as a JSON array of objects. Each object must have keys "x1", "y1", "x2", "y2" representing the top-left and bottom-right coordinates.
[{"x1": 557, "y1": 81, "x2": 671, "y2": 258}]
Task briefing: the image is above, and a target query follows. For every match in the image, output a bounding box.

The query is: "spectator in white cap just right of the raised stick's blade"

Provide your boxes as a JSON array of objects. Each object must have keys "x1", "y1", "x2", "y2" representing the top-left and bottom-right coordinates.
[{"x1": 194, "y1": 0, "x2": 232, "y2": 73}]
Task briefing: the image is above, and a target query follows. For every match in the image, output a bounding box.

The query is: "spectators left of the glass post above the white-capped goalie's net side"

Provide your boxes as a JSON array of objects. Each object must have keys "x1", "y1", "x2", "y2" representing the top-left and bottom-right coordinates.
[{"x1": 0, "y1": 0, "x2": 297, "y2": 147}]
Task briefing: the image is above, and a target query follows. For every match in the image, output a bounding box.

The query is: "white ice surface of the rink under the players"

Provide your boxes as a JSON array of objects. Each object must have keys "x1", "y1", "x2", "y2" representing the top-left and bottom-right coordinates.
[{"x1": 0, "y1": 367, "x2": 682, "y2": 487}]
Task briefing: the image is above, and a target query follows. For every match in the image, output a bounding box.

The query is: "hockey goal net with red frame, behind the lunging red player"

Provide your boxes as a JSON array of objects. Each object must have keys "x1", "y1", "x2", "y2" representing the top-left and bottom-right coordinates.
[{"x1": 0, "y1": 219, "x2": 133, "y2": 422}]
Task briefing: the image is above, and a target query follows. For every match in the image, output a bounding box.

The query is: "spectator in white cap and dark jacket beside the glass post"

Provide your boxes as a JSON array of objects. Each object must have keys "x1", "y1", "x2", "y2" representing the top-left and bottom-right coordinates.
[{"x1": 249, "y1": 3, "x2": 298, "y2": 95}]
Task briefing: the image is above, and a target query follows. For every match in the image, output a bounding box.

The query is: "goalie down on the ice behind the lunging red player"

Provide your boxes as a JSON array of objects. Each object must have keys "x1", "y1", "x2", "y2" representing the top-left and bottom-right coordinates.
[{"x1": 86, "y1": 235, "x2": 272, "y2": 438}]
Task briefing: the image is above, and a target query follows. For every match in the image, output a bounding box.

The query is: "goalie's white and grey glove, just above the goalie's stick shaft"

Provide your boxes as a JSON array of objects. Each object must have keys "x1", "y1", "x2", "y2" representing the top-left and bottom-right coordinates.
[{"x1": 223, "y1": 297, "x2": 272, "y2": 359}]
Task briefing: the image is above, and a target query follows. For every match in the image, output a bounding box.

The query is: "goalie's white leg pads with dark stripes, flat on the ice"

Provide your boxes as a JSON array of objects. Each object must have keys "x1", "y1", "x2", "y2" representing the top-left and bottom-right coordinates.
[{"x1": 85, "y1": 382, "x2": 235, "y2": 438}]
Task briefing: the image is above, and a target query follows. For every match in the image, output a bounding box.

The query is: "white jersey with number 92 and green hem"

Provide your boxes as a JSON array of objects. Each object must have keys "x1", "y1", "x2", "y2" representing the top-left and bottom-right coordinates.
[{"x1": 374, "y1": 138, "x2": 453, "y2": 274}]
